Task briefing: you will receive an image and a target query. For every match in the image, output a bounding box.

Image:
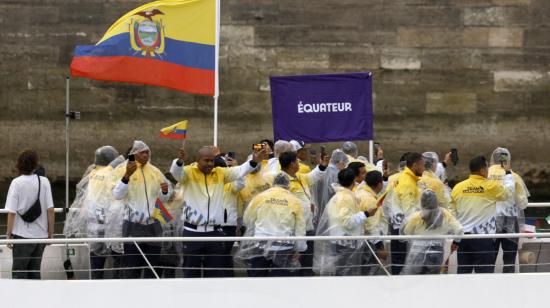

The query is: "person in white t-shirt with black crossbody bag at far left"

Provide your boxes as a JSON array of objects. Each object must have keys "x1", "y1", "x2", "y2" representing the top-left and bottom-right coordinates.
[{"x1": 6, "y1": 150, "x2": 55, "y2": 279}]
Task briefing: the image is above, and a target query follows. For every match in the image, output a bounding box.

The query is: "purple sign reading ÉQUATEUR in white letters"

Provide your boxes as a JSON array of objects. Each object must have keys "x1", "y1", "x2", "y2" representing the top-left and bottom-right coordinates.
[{"x1": 269, "y1": 73, "x2": 373, "y2": 143}]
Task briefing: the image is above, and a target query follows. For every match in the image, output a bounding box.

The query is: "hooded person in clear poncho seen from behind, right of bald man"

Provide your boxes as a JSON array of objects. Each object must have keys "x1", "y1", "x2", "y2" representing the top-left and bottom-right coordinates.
[{"x1": 234, "y1": 173, "x2": 307, "y2": 271}]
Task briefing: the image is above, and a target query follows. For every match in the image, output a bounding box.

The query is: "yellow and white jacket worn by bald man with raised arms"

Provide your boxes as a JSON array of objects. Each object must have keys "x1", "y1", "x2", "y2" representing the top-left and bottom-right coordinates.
[{"x1": 170, "y1": 159, "x2": 254, "y2": 232}]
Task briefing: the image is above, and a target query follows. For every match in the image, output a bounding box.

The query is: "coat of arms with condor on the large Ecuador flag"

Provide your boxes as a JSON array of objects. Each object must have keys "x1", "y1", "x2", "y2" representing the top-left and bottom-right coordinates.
[{"x1": 130, "y1": 9, "x2": 165, "y2": 58}]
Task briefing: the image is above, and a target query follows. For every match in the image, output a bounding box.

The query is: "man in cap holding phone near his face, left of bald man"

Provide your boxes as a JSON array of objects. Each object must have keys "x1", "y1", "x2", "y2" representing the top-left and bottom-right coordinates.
[{"x1": 112, "y1": 140, "x2": 172, "y2": 279}]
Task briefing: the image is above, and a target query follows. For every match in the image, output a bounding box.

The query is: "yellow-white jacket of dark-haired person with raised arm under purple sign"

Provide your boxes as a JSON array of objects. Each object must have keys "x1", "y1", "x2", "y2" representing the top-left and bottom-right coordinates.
[{"x1": 288, "y1": 166, "x2": 325, "y2": 231}]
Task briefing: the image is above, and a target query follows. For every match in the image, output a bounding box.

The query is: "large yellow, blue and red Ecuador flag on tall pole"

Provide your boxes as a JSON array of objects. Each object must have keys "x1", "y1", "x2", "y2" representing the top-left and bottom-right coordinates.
[{"x1": 71, "y1": 0, "x2": 219, "y2": 96}]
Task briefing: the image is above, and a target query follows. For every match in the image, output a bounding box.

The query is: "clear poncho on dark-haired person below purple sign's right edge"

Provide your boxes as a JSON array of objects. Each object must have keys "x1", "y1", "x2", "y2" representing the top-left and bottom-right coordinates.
[{"x1": 313, "y1": 184, "x2": 366, "y2": 276}]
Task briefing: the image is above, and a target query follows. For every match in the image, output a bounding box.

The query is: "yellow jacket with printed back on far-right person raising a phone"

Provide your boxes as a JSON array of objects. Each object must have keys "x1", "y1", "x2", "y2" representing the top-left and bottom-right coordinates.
[{"x1": 451, "y1": 174, "x2": 515, "y2": 234}]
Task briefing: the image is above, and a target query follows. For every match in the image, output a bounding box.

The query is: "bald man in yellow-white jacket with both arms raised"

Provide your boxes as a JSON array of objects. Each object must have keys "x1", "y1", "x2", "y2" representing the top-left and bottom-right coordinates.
[{"x1": 170, "y1": 147, "x2": 267, "y2": 277}]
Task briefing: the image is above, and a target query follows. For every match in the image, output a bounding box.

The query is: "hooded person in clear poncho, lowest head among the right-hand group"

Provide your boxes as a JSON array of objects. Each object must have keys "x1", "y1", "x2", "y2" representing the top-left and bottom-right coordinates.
[{"x1": 400, "y1": 189, "x2": 464, "y2": 275}]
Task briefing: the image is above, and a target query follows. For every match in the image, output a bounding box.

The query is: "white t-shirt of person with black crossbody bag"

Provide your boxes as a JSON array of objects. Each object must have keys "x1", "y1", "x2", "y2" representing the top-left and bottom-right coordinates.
[{"x1": 6, "y1": 174, "x2": 53, "y2": 238}]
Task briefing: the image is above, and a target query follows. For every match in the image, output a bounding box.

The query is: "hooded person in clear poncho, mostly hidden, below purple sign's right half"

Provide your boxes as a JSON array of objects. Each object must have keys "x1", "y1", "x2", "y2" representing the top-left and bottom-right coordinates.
[{"x1": 312, "y1": 149, "x2": 349, "y2": 224}]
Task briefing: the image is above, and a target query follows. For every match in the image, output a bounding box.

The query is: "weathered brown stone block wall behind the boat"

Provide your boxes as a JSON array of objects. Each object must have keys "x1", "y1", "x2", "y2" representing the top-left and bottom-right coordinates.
[{"x1": 0, "y1": 0, "x2": 550, "y2": 201}]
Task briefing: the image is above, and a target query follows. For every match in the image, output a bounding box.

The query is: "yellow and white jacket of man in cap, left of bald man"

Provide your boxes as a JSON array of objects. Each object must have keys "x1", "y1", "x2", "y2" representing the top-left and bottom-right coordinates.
[{"x1": 112, "y1": 161, "x2": 172, "y2": 224}]
